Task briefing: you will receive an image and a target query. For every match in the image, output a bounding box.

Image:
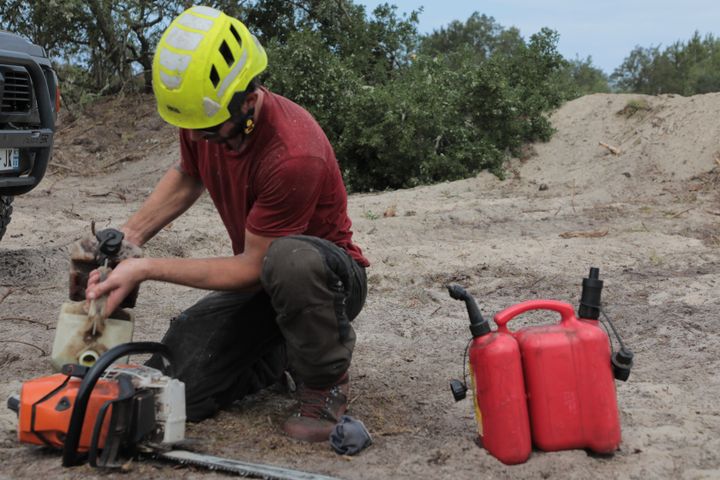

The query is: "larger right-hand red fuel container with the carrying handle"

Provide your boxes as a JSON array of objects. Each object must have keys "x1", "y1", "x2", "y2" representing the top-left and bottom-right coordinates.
[{"x1": 494, "y1": 300, "x2": 620, "y2": 453}]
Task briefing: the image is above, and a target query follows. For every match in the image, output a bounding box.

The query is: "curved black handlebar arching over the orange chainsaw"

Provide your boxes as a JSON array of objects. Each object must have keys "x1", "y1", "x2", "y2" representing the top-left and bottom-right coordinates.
[{"x1": 63, "y1": 342, "x2": 172, "y2": 467}]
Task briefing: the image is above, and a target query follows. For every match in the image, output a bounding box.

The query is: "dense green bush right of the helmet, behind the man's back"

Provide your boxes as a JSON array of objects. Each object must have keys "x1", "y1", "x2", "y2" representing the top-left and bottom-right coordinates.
[{"x1": 266, "y1": 23, "x2": 566, "y2": 191}]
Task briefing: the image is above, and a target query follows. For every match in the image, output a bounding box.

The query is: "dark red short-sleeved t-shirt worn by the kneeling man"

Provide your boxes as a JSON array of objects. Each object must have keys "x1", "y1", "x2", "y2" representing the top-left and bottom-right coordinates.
[{"x1": 180, "y1": 89, "x2": 369, "y2": 266}]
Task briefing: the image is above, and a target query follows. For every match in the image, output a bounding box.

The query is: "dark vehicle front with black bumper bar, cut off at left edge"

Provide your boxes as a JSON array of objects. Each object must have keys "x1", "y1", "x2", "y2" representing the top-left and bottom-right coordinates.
[{"x1": 0, "y1": 30, "x2": 60, "y2": 244}]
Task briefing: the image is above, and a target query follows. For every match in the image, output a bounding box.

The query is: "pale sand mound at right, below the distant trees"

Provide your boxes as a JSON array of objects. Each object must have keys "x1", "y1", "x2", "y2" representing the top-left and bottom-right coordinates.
[{"x1": 520, "y1": 93, "x2": 720, "y2": 193}]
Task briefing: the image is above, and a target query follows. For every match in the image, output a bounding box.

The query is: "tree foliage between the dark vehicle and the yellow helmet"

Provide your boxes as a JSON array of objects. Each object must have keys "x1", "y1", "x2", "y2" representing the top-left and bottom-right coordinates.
[{"x1": 0, "y1": 0, "x2": 182, "y2": 101}]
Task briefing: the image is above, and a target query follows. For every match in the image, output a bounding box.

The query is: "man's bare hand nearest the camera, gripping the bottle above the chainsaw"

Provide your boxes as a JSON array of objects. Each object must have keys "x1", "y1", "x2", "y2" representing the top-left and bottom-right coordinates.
[{"x1": 85, "y1": 258, "x2": 148, "y2": 316}]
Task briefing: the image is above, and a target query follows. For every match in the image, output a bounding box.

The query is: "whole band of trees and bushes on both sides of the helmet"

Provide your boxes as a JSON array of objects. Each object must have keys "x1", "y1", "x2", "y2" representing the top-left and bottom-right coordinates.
[{"x1": 0, "y1": 0, "x2": 592, "y2": 191}]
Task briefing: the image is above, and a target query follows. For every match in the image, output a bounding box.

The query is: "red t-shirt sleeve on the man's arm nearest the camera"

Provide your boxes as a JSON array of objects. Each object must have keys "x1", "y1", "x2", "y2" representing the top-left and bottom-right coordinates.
[{"x1": 246, "y1": 157, "x2": 327, "y2": 237}]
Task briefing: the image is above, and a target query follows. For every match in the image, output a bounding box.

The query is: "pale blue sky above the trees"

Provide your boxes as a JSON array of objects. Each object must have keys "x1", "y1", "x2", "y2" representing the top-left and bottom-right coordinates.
[{"x1": 355, "y1": 0, "x2": 720, "y2": 74}]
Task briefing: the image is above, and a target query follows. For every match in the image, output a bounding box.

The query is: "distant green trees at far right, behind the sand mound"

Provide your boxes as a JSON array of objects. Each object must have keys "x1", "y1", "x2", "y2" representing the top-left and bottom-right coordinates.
[{"x1": 610, "y1": 32, "x2": 720, "y2": 95}]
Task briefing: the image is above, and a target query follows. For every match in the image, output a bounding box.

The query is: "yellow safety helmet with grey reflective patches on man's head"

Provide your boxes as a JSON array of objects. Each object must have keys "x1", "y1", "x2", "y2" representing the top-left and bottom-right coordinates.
[{"x1": 153, "y1": 6, "x2": 267, "y2": 129}]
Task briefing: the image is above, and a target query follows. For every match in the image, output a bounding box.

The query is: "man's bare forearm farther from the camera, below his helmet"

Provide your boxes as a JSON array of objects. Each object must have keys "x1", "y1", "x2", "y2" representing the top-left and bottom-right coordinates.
[{"x1": 122, "y1": 167, "x2": 204, "y2": 246}]
